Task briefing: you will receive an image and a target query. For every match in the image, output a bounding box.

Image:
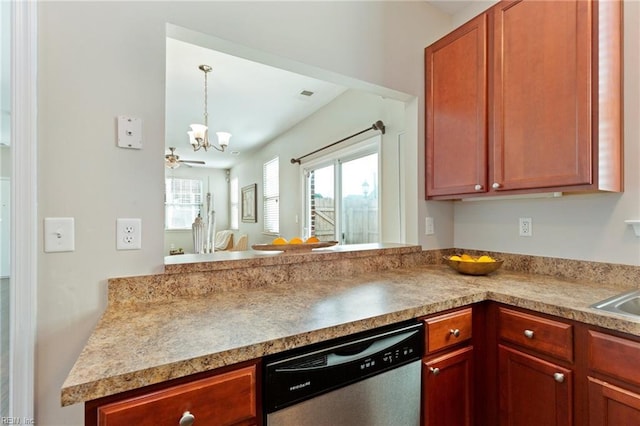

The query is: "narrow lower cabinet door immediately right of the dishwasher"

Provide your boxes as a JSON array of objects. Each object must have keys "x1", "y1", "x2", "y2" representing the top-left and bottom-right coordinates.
[{"x1": 422, "y1": 346, "x2": 473, "y2": 426}]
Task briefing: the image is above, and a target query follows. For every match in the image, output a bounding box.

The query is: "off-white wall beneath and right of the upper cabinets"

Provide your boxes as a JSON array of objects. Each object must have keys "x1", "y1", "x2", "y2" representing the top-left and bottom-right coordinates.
[{"x1": 420, "y1": 1, "x2": 640, "y2": 265}]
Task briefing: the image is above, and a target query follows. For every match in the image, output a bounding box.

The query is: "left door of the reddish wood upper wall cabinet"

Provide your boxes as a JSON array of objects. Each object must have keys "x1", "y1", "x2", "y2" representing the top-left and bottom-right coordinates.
[{"x1": 425, "y1": 14, "x2": 487, "y2": 197}]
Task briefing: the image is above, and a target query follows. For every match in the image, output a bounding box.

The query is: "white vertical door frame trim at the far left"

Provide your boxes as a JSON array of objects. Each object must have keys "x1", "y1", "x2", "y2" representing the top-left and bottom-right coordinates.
[{"x1": 9, "y1": 1, "x2": 38, "y2": 419}]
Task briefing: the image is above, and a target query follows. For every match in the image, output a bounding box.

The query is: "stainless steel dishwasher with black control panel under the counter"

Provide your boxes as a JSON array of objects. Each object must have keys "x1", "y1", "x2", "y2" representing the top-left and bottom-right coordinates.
[{"x1": 263, "y1": 323, "x2": 424, "y2": 426}]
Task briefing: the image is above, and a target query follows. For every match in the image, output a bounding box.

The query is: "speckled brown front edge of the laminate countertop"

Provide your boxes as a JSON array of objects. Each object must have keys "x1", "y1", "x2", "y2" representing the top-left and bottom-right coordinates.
[{"x1": 61, "y1": 272, "x2": 640, "y2": 406}]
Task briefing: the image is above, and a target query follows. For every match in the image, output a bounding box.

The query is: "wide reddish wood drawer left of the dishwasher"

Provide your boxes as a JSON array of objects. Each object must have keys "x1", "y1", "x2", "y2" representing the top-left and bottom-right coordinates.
[{"x1": 98, "y1": 366, "x2": 256, "y2": 426}]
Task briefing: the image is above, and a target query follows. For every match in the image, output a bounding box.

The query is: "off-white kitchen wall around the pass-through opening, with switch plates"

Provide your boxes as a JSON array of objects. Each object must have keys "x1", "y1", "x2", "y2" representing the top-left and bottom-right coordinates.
[{"x1": 36, "y1": 2, "x2": 450, "y2": 426}]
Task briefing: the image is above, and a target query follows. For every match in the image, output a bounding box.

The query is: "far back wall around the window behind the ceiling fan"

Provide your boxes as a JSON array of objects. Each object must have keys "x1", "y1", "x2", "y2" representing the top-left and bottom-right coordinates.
[{"x1": 163, "y1": 164, "x2": 229, "y2": 256}]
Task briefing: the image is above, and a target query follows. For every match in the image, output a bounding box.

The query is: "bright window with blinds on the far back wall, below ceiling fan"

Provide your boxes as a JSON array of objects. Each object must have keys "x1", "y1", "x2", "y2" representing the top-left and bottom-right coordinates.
[{"x1": 164, "y1": 178, "x2": 202, "y2": 229}]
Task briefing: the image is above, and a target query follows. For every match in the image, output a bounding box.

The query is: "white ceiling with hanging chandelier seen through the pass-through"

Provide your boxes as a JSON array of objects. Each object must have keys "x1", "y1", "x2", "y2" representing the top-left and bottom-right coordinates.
[{"x1": 165, "y1": 38, "x2": 347, "y2": 168}]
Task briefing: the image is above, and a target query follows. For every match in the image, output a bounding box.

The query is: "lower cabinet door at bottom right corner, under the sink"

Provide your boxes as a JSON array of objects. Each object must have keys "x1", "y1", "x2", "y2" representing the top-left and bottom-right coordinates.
[{"x1": 589, "y1": 377, "x2": 640, "y2": 426}]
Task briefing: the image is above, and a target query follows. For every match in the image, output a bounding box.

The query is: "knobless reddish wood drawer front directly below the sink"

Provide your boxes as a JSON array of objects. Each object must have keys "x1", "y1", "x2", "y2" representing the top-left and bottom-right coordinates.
[{"x1": 588, "y1": 330, "x2": 640, "y2": 386}]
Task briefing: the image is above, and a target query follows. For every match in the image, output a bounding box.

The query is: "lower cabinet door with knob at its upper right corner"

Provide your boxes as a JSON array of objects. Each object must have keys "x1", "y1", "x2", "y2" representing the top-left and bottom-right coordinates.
[{"x1": 498, "y1": 345, "x2": 573, "y2": 426}]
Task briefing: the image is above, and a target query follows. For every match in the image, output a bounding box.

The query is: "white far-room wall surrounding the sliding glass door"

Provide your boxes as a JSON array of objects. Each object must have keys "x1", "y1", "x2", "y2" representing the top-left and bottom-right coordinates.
[{"x1": 231, "y1": 90, "x2": 408, "y2": 244}]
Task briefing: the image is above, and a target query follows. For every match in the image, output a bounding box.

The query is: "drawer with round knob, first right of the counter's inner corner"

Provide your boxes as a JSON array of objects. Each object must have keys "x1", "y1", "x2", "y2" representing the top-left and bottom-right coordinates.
[{"x1": 498, "y1": 308, "x2": 573, "y2": 362}]
